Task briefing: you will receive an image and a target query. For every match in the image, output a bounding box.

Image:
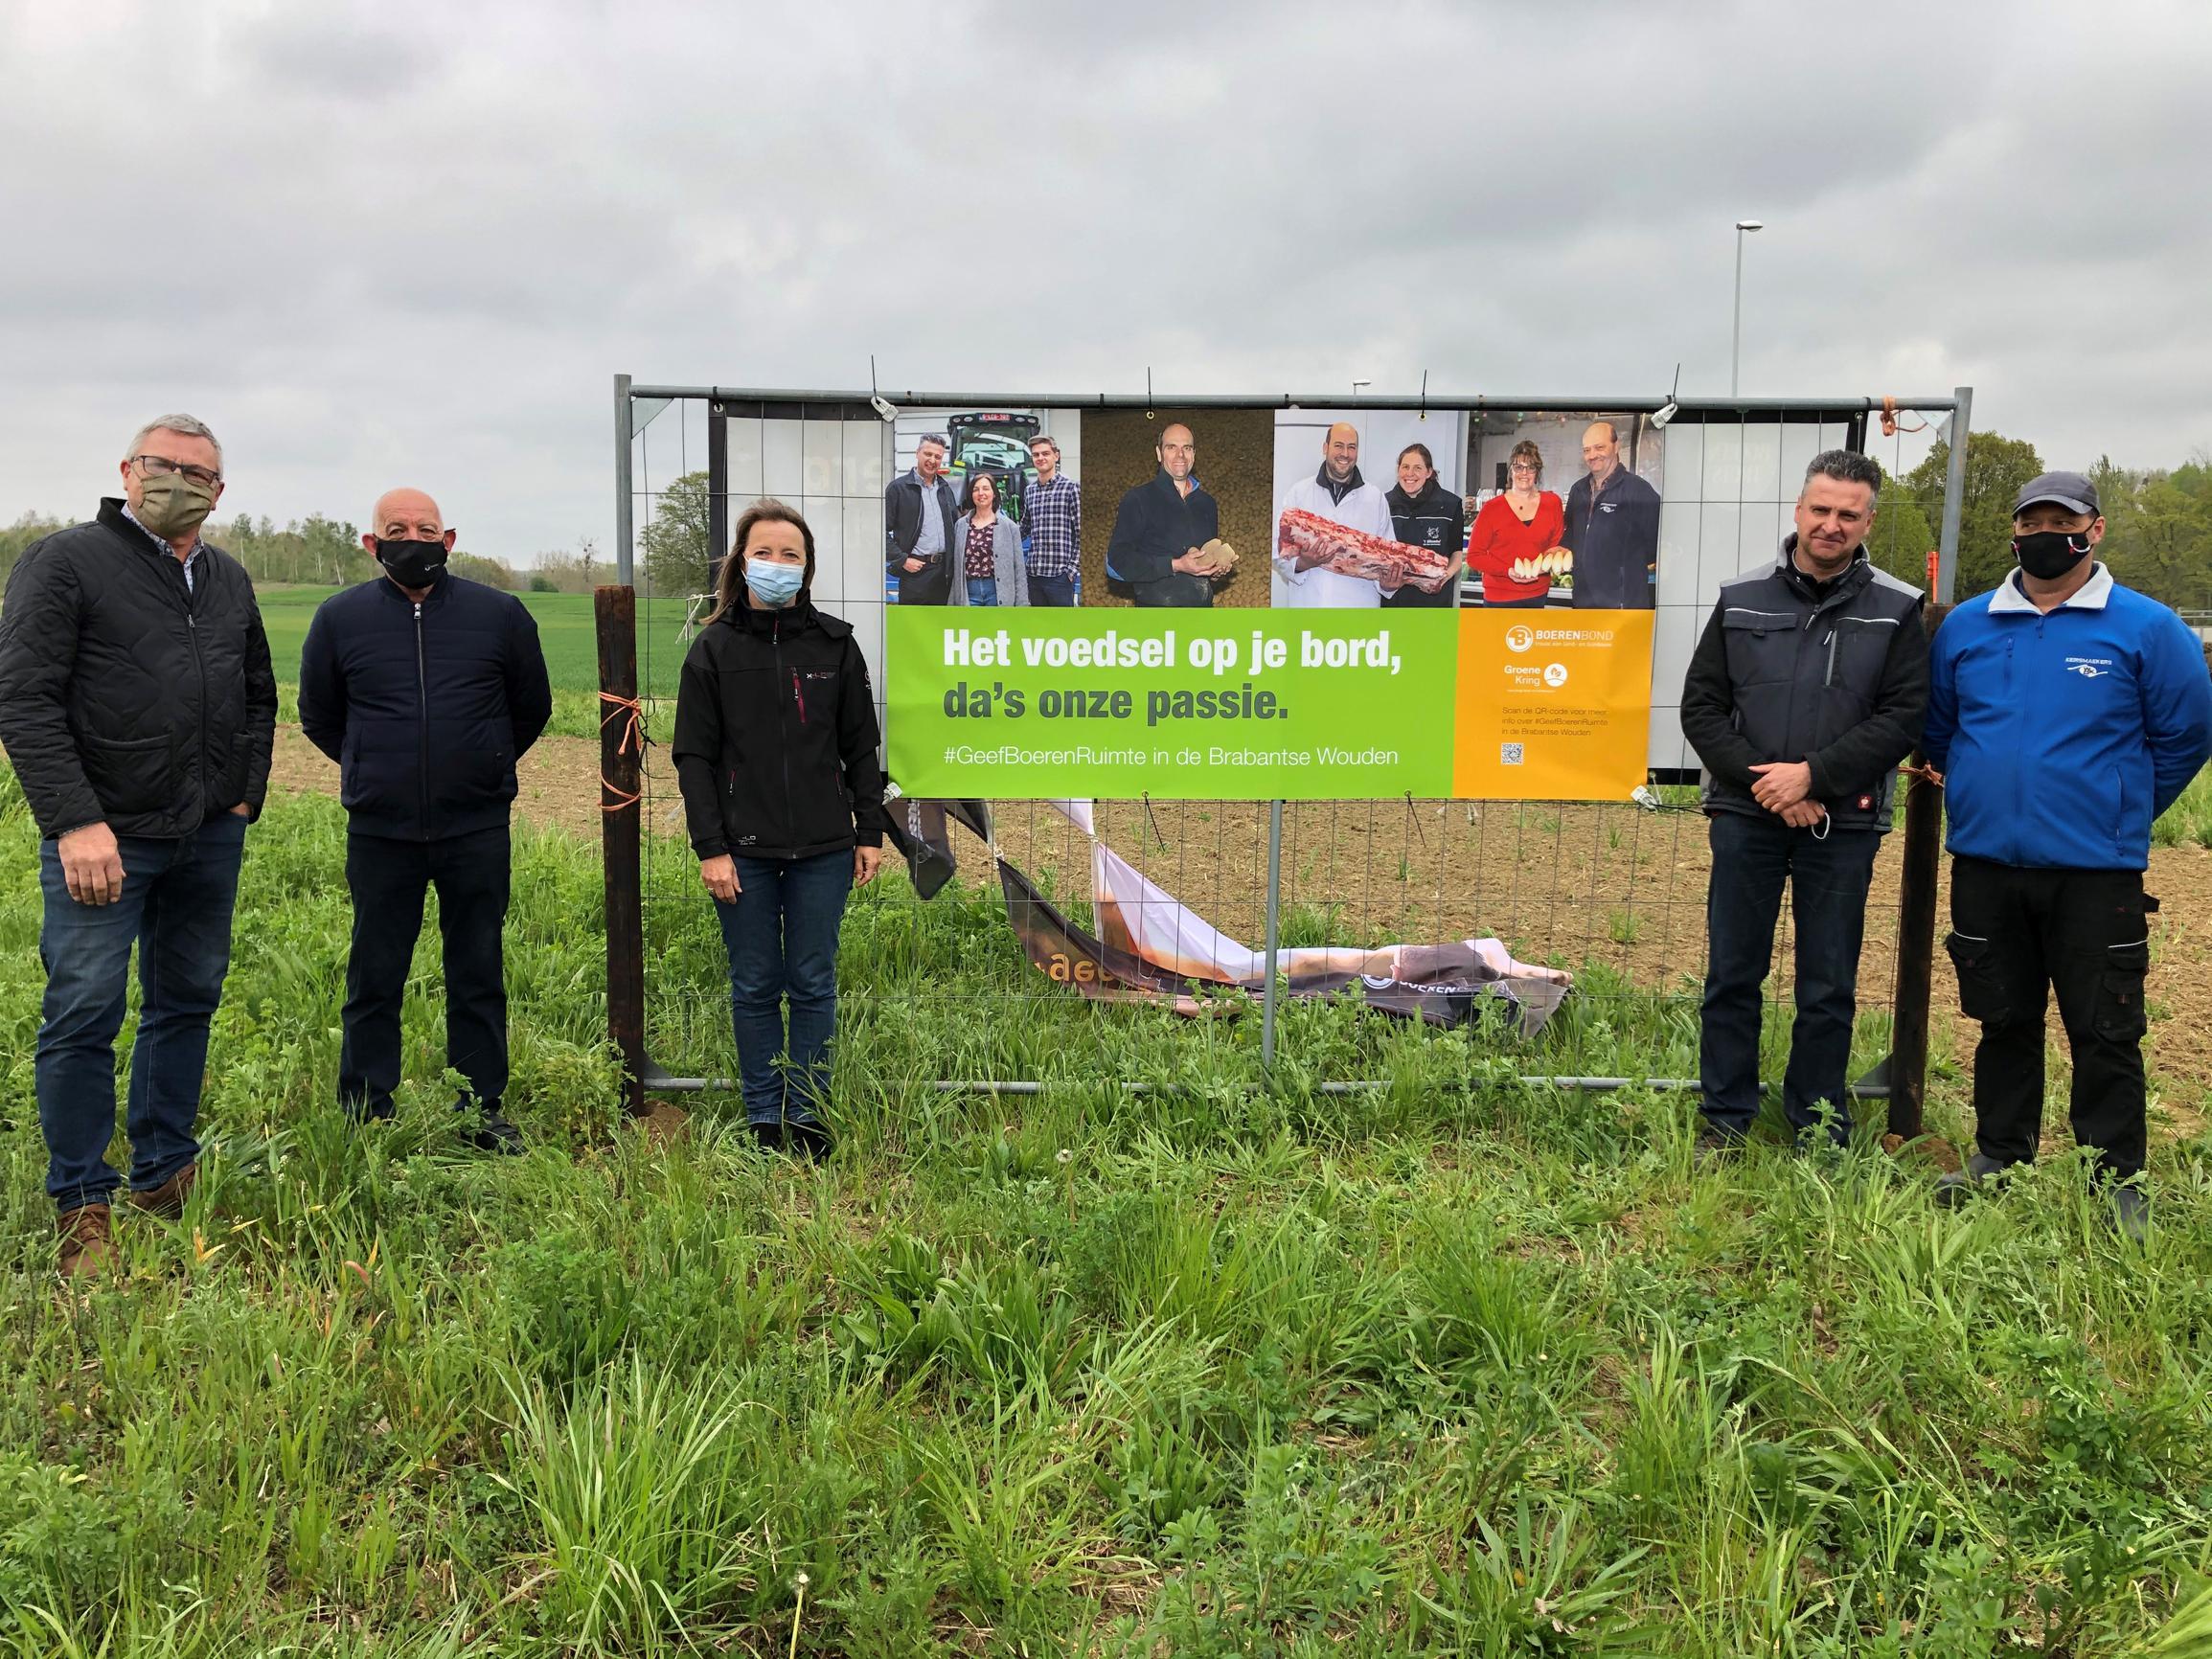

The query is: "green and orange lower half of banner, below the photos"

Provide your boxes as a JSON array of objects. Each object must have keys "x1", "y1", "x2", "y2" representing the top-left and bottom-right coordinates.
[{"x1": 885, "y1": 606, "x2": 1651, "y2": 801}]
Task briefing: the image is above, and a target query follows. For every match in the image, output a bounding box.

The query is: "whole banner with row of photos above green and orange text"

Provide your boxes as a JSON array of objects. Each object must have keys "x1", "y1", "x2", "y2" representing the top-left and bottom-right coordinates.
[{"x1": 882, "y1": 405, "x2": 1663, "y2": 801}]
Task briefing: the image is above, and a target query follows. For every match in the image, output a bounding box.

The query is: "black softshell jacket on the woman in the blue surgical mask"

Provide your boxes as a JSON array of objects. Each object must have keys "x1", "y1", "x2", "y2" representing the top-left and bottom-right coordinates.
[{"x1": 671, "y1": 598, "x2": 885, "y2": 858}]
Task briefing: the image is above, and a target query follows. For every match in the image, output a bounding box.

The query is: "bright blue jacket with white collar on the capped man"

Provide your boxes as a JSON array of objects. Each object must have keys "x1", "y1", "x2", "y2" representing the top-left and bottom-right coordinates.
[{"x1": 1923, "y1": 564, "x2": 2212, "y2": 870}]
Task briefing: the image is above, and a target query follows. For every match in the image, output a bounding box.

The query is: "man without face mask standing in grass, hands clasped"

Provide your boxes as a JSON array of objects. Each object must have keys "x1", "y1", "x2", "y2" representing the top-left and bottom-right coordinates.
[{"x1": 1680, "y1": 449, "x2": 1928, "y2": 1157}]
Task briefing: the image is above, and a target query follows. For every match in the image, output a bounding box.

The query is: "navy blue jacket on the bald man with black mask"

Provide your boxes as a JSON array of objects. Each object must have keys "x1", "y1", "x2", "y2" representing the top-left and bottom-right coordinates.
[{"x1": 299, "y1": 575, "x2": 553, "y2": 841}]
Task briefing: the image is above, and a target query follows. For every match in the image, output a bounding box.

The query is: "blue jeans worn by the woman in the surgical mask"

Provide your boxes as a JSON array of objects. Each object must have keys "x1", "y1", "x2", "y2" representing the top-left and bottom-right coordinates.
[{"x1": 715, "y1": 847, "x2": 852, "y2": 1124}]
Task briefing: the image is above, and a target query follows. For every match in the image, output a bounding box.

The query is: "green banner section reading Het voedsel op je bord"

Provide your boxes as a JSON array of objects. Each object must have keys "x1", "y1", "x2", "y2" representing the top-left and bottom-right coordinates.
[{"x1": 885, "y1": 606, "x2": 1458, "y2": 801}]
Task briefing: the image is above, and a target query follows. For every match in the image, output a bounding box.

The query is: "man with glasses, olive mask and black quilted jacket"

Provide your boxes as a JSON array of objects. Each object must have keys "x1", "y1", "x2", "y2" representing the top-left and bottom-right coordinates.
[{"x1": 0, "y1": 414, "x2": 277, "y2": 1276}]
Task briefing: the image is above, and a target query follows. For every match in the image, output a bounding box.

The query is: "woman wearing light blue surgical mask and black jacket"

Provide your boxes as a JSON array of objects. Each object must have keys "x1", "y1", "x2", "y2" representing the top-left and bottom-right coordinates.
[{"x1": 671, "y1": 500, "x2": 885, "y2": 1157}]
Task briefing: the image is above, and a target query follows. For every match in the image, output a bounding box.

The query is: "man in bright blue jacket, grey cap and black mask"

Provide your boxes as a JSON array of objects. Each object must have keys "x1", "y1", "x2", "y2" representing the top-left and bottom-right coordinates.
[{"x1": 1923, "y1": 473, "x2": 2212, "y2": 1237}]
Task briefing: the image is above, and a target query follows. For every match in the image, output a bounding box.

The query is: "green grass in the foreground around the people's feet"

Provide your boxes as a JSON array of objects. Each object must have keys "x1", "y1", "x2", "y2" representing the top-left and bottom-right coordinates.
[{"x1": 0, "y1": 772, "x2": 2212, "y2": 1659}]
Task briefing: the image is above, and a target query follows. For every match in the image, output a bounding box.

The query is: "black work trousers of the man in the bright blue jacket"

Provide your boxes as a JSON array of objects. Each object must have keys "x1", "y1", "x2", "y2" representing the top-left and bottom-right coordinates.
[{"x1": 1945, "y1": 858, "x2": 2159, "y2": 1177}]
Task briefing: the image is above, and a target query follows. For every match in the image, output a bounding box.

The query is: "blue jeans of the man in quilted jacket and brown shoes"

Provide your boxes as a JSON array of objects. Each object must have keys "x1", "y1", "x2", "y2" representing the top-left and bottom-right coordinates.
[{"x1": 34, "y1": 812, "x2": 245, "y2": 1210}]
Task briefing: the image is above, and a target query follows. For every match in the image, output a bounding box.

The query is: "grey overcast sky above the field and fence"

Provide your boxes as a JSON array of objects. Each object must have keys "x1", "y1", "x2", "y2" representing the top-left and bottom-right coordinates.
[{"x1": 0, "y1": 0, "x2": 2212, "y2": 564}]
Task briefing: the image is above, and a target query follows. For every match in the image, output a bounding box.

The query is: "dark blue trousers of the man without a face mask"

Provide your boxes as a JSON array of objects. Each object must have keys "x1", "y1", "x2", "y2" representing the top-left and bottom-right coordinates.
[{"x1": 1697, "y1": 812, "x2": 1882, "y2": 1142}]
